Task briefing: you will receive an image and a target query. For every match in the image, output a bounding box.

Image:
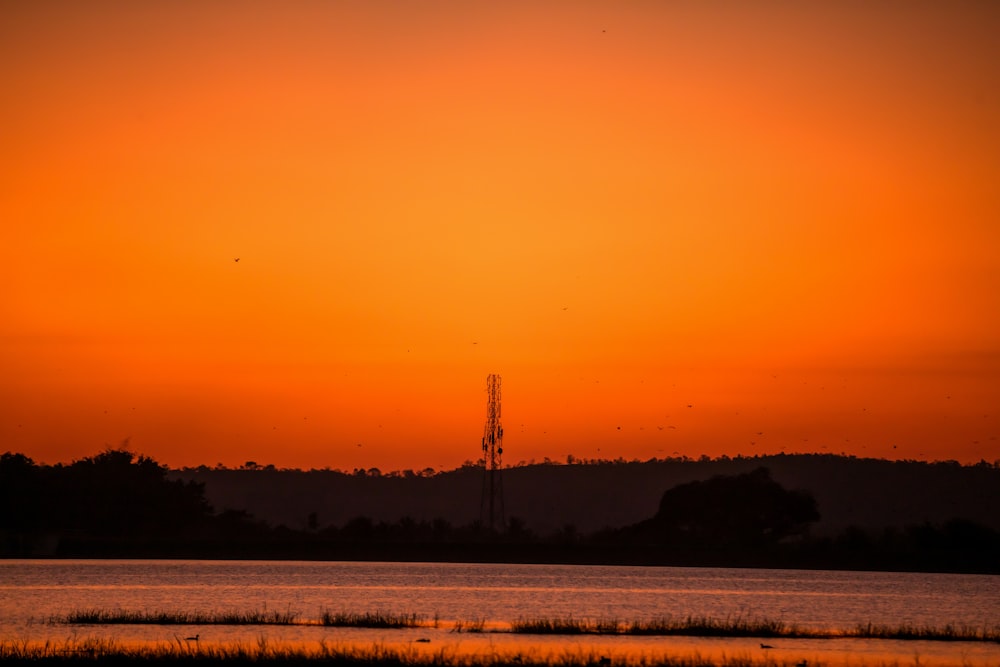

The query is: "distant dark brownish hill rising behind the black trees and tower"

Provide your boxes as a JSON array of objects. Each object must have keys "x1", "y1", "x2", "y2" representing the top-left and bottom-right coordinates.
[{"x1": 170, "y1": 454, "x2": 1000, "y2": 536}]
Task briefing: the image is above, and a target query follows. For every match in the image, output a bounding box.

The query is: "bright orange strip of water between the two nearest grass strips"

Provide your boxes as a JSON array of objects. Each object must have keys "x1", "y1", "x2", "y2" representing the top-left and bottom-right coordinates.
[{"x1": 47, "y1": 628, "x2": 1000, "y2": 667}]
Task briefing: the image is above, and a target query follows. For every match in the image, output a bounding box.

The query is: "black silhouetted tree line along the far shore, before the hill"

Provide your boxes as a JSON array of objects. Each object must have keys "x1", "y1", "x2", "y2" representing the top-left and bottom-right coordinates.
[{"x1": 0, "y1": 448, "x2": 1000, "y2": 572}]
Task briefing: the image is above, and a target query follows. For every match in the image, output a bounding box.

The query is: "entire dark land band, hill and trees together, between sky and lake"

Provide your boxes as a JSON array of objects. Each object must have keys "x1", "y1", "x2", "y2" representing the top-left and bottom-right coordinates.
[{"x1": 0, "y1": 449, "x2": 1000, "y2": 573}]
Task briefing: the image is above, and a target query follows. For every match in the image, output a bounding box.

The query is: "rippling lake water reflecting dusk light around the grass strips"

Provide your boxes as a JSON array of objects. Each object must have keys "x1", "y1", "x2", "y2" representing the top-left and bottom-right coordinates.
[{"x1": 0, "y1": 560, "x2": 1000, "y2": 666}]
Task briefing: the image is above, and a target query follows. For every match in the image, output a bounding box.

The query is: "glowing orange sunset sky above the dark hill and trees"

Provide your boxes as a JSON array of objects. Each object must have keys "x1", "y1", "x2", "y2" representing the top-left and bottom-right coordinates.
[{"x1": 0, "y1": 0, "x2": 1000, "y2": 470}]
